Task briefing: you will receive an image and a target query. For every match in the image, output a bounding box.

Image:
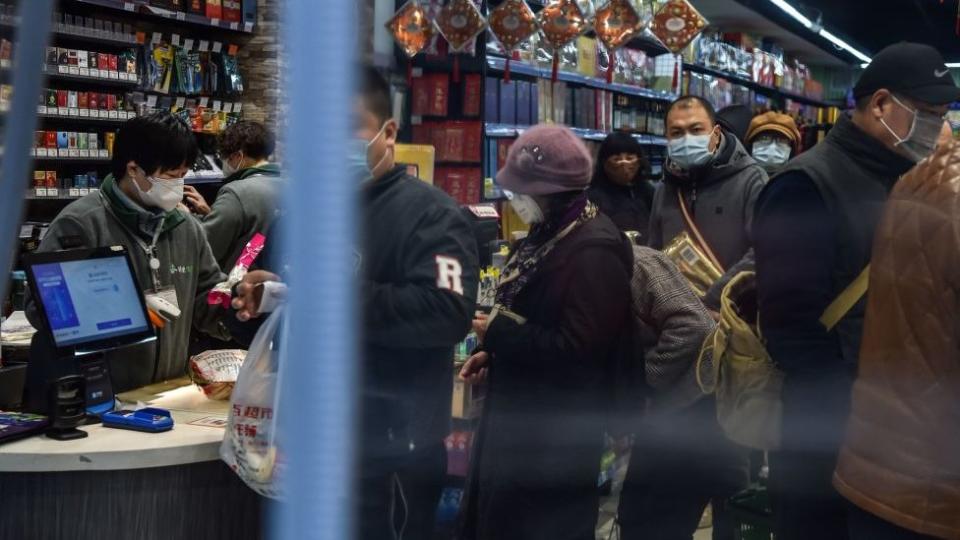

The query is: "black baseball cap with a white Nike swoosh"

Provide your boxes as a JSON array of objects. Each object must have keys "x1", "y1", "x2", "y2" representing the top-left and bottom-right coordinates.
[{"x1": 853, "y1": 41, "x2": 960, "y2": 105}]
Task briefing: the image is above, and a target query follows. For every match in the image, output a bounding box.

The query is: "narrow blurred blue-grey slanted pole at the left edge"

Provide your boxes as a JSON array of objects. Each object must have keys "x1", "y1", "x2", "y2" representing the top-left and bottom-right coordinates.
[{"x1": 0, "y1": 0, "x2": 53, "y2": 298}]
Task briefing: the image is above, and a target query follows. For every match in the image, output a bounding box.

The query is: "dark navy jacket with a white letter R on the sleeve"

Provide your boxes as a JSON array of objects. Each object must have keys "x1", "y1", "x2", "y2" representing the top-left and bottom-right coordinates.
[{"x1": 357, "y1": 167, "x2": 479, "y2": 464}]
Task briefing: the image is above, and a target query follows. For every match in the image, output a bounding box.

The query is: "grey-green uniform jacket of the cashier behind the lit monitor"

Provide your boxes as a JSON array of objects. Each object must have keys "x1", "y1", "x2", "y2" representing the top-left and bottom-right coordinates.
[{"x1": 27, "y1": 176, "x2": 229, "y2": 392}]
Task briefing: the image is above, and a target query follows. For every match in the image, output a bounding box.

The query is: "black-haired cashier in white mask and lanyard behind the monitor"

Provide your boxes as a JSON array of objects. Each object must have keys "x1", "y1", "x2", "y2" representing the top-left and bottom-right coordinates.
[{"x1": 27, "y1": 113, "x2": 229, "y2": 391}]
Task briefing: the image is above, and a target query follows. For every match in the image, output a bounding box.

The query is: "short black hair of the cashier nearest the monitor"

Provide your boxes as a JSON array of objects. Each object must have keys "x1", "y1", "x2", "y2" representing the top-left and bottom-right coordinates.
[{"x1": 110, "y1": 112, "x2": 199, "y2": 181}]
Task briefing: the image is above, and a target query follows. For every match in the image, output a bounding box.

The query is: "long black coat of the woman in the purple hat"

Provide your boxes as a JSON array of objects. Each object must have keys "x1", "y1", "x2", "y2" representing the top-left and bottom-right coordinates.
[{"x1": 462, "y1": 214, "x2": 633, "y2": 540}]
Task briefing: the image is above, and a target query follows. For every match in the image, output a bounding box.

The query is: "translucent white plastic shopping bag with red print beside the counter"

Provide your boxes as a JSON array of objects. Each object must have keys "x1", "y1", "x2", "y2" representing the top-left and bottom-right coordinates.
[{"x1": 220, "y1": 309, "x2": 284, "y2": 499}]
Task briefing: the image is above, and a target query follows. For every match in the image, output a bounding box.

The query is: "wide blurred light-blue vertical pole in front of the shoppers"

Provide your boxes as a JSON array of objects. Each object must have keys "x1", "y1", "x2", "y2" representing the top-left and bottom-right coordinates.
[{"x1": 271, "y1": 0, "x2": 359, "y2": 540}]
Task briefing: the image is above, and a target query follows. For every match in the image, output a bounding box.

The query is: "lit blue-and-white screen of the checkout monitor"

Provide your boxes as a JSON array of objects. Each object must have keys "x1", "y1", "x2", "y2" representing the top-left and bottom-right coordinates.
[{"x1": 30, "y1": 247, "x2": 152, "y2": 348}]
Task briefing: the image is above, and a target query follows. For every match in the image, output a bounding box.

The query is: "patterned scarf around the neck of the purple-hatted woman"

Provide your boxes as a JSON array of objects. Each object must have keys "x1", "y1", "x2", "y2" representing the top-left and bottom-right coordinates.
[{"x1": 497, "y1": 193, "x2": 598, "y2": 311}]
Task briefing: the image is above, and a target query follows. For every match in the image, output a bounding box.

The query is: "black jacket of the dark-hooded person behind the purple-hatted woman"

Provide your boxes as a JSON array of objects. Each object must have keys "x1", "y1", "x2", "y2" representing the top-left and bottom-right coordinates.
[{"x1": 587, "y1": 175, "x2": 655, "y2": 240}]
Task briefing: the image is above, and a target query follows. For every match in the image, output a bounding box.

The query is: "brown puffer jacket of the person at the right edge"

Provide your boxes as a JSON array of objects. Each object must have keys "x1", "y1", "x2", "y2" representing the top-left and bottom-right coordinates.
[{"x1": 834, "y1": 143, "x2": 960, "y2": 539}]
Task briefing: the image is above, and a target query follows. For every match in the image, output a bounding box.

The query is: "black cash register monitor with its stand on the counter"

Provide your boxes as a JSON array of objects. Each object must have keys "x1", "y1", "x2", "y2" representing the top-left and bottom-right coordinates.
[{"x1": 24, "y1": 246, "x2": 156, "y2": 414}]
